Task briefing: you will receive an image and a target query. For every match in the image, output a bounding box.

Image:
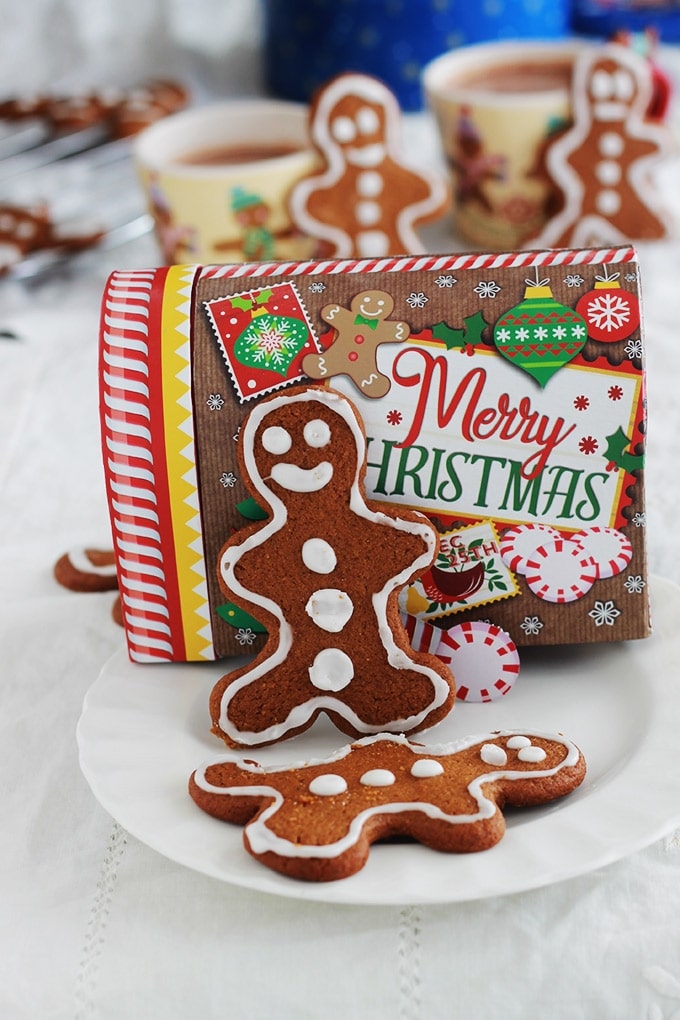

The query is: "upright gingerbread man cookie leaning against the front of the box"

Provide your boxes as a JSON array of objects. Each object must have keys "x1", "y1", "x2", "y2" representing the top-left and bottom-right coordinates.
[{"x1": 210, "y1": 387, "x2": 455, "y2": 747}]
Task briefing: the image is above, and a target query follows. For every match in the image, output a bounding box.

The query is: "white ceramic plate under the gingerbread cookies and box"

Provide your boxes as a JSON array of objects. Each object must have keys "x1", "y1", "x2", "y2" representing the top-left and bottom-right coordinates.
[{"x1": 77, "y1": 578, "x2": 680, "y2": 904}]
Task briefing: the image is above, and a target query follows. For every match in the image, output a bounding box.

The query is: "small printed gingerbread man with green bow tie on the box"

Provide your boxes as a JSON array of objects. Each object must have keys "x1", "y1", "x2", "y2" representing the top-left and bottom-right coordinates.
[{"x1": 302, "y1": 291, "x2": 410, "y2": 397}]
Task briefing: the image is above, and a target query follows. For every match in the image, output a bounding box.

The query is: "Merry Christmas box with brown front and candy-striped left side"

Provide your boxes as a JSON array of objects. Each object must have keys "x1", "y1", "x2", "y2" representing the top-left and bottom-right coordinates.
[{"x1": 100, "y1": 247, "x2": 649, "y2": 661}]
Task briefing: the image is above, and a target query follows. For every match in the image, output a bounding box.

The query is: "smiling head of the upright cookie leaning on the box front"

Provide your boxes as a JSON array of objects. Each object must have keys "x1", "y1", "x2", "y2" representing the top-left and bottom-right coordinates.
[{"x1": 243, "y1": 388, "x2": 363, "y2": 503}]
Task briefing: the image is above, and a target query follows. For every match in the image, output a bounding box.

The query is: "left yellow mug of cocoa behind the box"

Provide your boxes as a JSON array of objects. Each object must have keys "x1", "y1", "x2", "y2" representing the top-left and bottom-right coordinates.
[{"x1": 134, "y1": 99, "x2": 317, "y2": 265}]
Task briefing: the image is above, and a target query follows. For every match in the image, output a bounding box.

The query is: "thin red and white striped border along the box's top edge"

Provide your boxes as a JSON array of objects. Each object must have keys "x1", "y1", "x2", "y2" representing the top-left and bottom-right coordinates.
[{"x1": 200, "y1": 247, "x2": 635, "y2": 279}]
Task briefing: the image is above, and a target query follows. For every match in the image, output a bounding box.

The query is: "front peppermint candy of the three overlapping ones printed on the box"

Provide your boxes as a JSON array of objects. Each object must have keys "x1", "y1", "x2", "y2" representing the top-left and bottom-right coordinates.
[{"x1": 525, "y1": 539, "x2": 597, "y2": 603}]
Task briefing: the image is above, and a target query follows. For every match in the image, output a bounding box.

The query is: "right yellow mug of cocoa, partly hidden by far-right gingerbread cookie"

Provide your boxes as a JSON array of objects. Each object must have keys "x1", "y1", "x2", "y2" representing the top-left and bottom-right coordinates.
[{"x1": 423, "y1": 42, "x2": 585, "y2": 251}]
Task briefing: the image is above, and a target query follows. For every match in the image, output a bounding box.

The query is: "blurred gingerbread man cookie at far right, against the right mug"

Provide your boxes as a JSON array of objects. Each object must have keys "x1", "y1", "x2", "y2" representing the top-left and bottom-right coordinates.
[{"x1": 531, "y1": 44, "x2": 669, "y2": 248}]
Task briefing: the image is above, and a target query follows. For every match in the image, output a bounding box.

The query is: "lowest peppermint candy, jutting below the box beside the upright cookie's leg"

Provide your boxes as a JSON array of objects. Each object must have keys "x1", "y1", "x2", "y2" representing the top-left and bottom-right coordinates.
[{"x1": 436, "y1": 620, "x2": 520, "y2": 702}]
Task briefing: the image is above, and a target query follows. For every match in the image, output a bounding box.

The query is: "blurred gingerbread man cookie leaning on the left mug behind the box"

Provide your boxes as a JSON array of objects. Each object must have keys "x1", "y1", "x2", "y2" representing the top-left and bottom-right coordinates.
[{"x1": 290, "y1": 73, "x2": 450, "y2": 258}]
